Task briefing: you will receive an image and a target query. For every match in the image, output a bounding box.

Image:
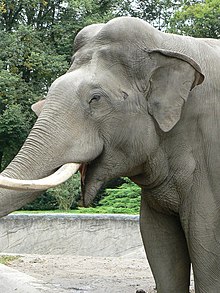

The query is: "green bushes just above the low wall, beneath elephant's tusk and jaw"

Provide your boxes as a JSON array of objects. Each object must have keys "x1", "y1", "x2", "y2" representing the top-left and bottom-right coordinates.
[{"x1": 23, "y1": 174, "x2": 141, "y2": 214}]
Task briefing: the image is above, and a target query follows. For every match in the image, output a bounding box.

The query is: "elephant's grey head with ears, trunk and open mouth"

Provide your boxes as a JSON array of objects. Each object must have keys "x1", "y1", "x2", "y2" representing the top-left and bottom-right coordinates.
[{"x1": 0, "y1": 17, "x2": 203, "y2": 214}]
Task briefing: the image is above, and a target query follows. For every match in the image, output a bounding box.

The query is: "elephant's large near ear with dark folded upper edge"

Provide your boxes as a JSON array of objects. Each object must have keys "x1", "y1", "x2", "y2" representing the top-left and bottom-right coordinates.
[{"x1": 148, "y1": 50, "x2": 204, "y2": 132}]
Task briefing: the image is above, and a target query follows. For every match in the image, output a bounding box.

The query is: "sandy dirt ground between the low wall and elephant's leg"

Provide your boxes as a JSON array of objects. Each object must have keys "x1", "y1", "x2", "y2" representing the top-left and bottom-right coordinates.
[{"x1": 7, "y1": 255, "x2": 193, "y2": 293}]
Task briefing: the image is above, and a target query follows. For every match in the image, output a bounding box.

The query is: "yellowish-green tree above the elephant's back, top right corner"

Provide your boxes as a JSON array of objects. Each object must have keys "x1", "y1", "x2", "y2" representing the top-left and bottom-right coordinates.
[{"x1": 170, "y1": 0, "x2": 220, "y2": 38}]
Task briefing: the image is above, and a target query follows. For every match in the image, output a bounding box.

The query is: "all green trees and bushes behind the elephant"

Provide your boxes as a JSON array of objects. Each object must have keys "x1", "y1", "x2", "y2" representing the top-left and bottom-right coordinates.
[{"x1": 0, "y1": 0, "x2": 220, "y2": 212}]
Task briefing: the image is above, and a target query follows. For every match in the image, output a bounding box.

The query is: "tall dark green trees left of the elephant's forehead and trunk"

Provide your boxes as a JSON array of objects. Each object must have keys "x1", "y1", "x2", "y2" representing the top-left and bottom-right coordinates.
[{"x1": 0, "y1": 0, "x2": 117, "y2": 169}]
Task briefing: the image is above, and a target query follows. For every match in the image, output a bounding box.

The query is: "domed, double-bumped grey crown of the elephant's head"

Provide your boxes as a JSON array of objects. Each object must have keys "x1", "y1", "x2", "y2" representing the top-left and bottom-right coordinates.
[{"x1": 71, "y1": 17, "x2": 159, "y2": 70}]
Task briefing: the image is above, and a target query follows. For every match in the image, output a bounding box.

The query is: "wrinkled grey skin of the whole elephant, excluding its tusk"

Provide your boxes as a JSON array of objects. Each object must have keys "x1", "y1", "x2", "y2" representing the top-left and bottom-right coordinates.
[{"x1": 0, "y1": 17, "x2": 220, "y2": 293}]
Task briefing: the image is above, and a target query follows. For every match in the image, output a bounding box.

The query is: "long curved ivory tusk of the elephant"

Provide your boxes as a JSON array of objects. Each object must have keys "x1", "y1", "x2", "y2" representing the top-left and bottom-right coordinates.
[{"x1": 0, "y1": 163, "x2": 80, "y2": 190}]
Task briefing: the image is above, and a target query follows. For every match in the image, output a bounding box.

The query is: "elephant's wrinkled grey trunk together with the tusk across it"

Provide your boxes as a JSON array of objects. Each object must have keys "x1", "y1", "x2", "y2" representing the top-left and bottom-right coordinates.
[{"x1": 0, "y1": 115, "x2": 76, "y2": 217}]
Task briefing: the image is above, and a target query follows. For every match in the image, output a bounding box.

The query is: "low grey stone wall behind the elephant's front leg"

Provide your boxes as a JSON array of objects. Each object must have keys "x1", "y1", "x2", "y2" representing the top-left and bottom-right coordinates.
[{"x1": 0, "y1": 214, "x2": 144, "y2": 257}]
